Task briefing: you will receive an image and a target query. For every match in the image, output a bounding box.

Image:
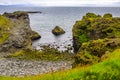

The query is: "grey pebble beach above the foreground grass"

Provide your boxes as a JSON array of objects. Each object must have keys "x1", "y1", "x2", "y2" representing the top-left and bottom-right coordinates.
[{"x1": 0, "y1": 58, "x2": 72, "y2": 76}]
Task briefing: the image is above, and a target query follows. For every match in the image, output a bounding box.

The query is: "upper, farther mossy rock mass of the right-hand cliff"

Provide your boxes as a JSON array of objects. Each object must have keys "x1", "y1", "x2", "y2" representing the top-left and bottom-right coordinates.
[{"x1": 73, "y1": 13, "x2": 120, "y2": 52}]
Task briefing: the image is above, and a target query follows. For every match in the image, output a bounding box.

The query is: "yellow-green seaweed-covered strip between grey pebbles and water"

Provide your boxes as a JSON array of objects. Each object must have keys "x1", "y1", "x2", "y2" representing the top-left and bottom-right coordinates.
[{"x1": 8, "y1": 46, "x2": 72, "y2": 61}]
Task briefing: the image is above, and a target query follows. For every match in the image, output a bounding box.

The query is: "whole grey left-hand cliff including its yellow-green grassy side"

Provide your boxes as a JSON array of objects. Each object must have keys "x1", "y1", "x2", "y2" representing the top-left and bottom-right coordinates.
[{"x1": 0, "y1": 11, "x2": 40, "y2": 56}]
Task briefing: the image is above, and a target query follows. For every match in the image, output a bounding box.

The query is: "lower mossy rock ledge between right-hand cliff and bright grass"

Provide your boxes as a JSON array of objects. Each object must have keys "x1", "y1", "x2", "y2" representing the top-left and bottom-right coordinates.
[{"x1": 74, "y1": 38, "x2": 120, "y2": 66}]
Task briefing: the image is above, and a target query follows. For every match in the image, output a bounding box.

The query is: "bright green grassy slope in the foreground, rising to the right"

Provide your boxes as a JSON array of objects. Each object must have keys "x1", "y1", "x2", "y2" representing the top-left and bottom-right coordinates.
[{"x1": 0, "y1": 49, "x2": 120, "y2": 80}]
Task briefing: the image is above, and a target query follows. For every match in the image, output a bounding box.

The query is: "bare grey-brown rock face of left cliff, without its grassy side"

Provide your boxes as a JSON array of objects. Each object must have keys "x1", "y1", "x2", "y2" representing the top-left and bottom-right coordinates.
[{"x1": 0, "y1": 12, "x2": 40, "y2": 57}]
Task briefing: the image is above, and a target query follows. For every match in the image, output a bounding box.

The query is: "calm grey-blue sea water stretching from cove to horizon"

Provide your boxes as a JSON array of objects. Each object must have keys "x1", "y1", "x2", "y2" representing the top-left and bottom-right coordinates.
[{"x1": 0, "y1": 7, "x2": 120, "y2": 50}]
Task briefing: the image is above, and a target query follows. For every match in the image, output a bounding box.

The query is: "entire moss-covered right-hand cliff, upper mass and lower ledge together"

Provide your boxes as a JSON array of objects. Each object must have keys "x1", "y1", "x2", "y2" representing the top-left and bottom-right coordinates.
[{"x1": 73, "y1": 13, "x2": 120, "y2": 65}]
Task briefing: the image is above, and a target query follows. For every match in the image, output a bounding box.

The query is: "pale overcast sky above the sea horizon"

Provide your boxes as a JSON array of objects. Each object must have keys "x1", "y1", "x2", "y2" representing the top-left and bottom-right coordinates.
[{"x1": 0, "y1": 0, "x2": 120, "y2": 6}]
